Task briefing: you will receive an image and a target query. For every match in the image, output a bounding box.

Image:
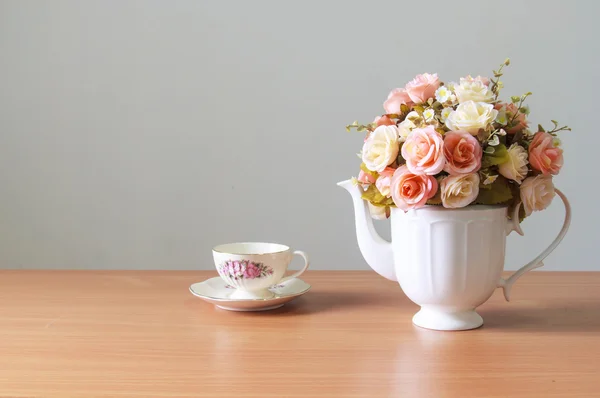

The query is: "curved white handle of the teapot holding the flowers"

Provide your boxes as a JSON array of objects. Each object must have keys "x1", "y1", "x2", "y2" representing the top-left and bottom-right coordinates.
[{"x1": 498, "y1": 189, "x2": 571, "y2": 301}]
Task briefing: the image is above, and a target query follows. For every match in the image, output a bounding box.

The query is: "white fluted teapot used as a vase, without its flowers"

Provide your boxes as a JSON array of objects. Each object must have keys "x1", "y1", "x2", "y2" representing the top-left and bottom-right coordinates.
[{"x1": 338, "y1": 180, "x2": 571, "y2": 330}]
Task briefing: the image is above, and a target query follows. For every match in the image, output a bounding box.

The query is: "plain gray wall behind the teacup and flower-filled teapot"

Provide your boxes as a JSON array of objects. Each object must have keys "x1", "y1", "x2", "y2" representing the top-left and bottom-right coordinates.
[{"x1": 0, "y1": 0, "x2": 600, "y2": 270}]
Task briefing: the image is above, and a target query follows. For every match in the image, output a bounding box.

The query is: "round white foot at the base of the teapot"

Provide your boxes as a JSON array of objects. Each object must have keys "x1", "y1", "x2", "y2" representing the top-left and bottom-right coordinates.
[{"x1": 413, "y1": 306, "x2": 483, "y2": 330}]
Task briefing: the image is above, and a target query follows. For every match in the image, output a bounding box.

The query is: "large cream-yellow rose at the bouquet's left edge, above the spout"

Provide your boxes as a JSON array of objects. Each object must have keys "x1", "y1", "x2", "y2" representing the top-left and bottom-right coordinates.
[{"x1": 362, "y1": 126, "x2": 400, "y2": 173}]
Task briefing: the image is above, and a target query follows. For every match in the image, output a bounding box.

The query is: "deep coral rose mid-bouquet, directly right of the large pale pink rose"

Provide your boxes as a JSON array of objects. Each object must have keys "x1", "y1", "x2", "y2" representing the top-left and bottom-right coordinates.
[{"x1": 444, "y1": 131, "x2": 482, "y2": 175}]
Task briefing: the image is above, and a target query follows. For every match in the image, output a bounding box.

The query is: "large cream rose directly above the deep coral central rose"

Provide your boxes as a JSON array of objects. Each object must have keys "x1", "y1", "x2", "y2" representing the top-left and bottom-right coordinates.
[{"x1": 446, "y1": 101, "x2": 498, "y2": 135}]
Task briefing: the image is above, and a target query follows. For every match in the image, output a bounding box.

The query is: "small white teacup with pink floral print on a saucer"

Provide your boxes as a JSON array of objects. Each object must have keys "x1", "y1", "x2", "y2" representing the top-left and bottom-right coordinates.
[{"x1": 213, "y1": 242, "x2": 309, "y2": 299}]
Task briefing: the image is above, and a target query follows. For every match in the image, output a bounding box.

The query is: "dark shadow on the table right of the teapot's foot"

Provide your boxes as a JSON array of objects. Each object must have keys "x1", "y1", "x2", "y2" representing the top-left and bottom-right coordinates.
[{"x1": 478, "y1": 303, "x2": 600, "y2": 332}]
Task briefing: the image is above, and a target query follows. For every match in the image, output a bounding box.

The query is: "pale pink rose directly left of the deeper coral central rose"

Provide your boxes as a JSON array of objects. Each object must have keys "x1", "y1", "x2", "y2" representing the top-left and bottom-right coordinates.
[{"x1": 402, "y1": 125, "x2": 446, "y2": 175}]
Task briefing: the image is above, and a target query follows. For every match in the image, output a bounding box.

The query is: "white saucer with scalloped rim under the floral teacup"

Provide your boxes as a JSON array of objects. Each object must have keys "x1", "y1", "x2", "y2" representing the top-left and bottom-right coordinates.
[{"x1": 190, "y1": 276, "x2": 310, "y2": 311}]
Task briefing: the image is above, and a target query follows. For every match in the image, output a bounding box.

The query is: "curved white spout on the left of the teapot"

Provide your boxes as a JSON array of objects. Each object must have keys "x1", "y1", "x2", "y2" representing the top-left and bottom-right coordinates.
[{"x1": 337, "y1": 180, "x2": 398, "y2": 281}]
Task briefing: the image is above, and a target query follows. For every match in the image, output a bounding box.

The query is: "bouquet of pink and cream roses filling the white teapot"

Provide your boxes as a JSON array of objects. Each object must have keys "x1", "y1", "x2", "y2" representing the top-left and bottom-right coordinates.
[{"x1": 346, "y1": 59, "x2": 571, "y2": 221}]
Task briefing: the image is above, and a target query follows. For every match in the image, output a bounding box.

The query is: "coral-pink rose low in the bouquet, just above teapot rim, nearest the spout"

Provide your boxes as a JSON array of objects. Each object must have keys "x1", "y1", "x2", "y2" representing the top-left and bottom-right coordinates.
[{"x1": 390, "y1": 165, "x2": 438, "y2": 211}]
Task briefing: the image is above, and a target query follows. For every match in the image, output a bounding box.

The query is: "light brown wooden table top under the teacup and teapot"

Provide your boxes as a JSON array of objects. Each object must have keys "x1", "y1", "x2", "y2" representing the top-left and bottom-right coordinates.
[{"x1": 0, "y1": 271, "x2": 600, "y2": 398}]
